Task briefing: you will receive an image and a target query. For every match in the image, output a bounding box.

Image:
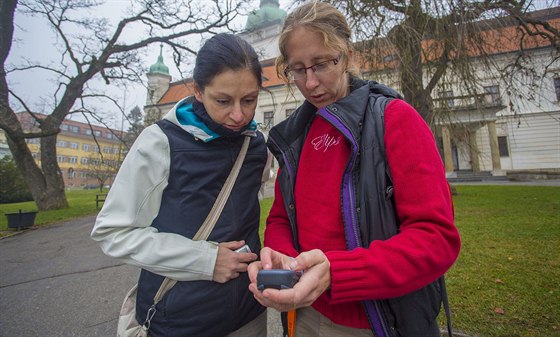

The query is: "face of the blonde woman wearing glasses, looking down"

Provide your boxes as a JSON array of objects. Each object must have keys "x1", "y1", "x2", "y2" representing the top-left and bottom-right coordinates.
[{"x1": 286, "y1": 27, "x2": 349, "y2": 109}]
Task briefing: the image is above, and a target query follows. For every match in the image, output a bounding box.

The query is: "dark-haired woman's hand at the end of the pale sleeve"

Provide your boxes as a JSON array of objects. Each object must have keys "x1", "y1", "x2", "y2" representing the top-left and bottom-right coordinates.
[{"x1": 212, "y1": 240, "x2": 258, "y2": 283}]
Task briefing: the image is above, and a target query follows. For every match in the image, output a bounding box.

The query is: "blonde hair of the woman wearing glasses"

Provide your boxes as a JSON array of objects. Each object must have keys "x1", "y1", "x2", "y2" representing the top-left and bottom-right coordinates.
[{"x1": 276, "y1": 1, "x2": 352, "y2": 82}]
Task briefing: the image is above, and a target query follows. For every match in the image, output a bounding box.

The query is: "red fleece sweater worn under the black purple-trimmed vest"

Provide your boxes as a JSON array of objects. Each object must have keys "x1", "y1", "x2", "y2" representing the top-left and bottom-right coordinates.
[{"x1": 264, "y1": 100, "x2": 461, "y2": 328}]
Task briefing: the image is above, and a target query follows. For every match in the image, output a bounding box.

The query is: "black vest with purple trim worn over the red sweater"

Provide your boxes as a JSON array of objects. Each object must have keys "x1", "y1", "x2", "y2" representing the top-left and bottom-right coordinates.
[{"x1": 267, "y1": 79, "x2": 441, "y2": 337}]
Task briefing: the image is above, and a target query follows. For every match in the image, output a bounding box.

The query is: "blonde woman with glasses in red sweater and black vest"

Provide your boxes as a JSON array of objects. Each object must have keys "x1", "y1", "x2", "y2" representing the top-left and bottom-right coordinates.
[{"x1": 249, "y1": 2, "x2": 461, "y2": 337}]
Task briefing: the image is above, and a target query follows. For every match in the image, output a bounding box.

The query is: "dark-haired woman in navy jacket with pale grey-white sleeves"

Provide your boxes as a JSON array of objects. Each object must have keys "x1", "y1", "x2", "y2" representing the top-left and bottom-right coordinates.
[{"x1": 91, "y1": 34, "x2": 268, "y2": 337}]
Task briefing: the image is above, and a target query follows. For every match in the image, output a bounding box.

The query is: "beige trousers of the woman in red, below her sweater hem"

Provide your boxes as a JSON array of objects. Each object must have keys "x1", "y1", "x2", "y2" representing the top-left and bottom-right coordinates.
[{"x1": 295, "y1": 307, "x2": 375, "y2": 337}]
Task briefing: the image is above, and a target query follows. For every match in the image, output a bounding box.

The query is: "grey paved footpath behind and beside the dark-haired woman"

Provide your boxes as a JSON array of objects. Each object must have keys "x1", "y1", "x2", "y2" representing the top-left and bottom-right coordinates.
[{"x1": 0, "y1": 216, "x2": 281, "y2": 337}]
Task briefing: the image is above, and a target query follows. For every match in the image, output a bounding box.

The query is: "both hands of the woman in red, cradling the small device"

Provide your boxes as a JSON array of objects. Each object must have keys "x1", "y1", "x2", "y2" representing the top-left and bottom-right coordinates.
[{"x1": 249, "y1": 248, "x2": 331, "y2": 311}]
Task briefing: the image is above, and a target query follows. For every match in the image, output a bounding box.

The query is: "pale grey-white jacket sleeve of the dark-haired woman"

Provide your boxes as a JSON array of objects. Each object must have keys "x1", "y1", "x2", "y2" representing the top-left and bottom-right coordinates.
[{"x1": 91, "y1": 125, "x2": 218, "y2": 281}]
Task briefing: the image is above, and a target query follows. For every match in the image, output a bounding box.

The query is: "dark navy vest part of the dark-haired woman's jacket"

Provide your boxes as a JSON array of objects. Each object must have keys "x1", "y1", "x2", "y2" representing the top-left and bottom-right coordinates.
[{"x1": 136, "y1": 120, "x2": 267, "y2": 337}]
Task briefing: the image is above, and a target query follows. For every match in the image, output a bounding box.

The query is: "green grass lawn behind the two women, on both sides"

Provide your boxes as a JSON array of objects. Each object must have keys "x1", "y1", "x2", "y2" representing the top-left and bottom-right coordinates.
[{"x1": 0, "y1": 185, "x2": 560, "y2": 337}]
